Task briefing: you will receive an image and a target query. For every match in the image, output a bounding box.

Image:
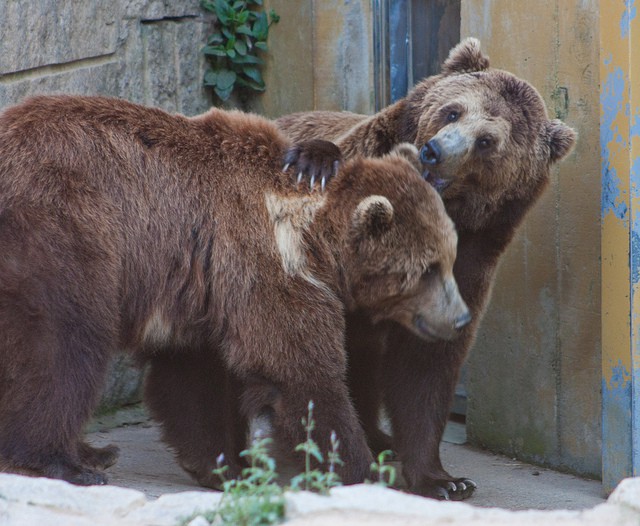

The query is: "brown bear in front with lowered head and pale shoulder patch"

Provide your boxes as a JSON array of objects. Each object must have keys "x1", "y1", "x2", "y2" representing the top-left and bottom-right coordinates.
[{"x1": 0, "y1": 96, "x2": 469, "y2": 484}]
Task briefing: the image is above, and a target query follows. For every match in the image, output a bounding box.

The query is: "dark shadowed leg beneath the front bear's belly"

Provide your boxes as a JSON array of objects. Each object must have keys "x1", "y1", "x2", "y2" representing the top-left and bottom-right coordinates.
[{"x1": 144, "y1": 348, "x2": 248, "y2": 489}]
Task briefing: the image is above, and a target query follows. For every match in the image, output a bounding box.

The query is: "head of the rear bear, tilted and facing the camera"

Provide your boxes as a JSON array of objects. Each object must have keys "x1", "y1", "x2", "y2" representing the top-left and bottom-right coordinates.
[{"x1": 403, "y1": 38, "x2": 576, "y2": 230}]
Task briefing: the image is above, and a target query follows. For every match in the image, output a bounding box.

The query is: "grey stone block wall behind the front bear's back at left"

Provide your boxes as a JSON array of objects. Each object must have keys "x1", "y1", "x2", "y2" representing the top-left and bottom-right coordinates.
[{"x1": 0, "y1": 0, "x2": 211, "y2": 410}]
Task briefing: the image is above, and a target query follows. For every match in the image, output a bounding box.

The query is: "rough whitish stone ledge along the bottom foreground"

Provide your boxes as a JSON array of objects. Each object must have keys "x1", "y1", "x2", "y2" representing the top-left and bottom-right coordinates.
[{"x1": 0, "y1": 474, "x2": 640, "y2": 526}]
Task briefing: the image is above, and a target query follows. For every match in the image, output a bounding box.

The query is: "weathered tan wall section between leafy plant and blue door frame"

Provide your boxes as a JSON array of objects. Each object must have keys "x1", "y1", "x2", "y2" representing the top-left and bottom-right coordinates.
[{"x1": 250, "y1": 0, "x2": 374, "y2": 117}]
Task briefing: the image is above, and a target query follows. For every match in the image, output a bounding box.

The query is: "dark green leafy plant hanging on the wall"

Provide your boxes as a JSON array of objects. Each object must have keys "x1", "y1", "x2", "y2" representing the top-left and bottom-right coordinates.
[{"x1": 201, "y1": 0, "x2": 280, "y2": 101}]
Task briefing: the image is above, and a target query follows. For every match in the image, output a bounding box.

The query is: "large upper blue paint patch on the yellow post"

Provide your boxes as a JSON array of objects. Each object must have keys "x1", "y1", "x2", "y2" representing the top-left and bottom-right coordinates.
[{"x1": 600, "y1": 67, "x2": 628, "y2": 221}]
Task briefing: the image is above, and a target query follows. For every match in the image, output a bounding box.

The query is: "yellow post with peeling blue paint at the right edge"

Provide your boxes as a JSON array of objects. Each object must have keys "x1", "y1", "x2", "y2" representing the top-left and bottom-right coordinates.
[{"x1": 600, "y1": 0, "x2": 640, "y2": 491}]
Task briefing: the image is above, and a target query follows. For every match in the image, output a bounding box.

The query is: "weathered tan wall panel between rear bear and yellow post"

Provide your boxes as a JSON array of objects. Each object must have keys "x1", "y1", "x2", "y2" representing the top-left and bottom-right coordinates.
[{"x1": 461, "y1": 0, "x2": 601, "y2": 476}]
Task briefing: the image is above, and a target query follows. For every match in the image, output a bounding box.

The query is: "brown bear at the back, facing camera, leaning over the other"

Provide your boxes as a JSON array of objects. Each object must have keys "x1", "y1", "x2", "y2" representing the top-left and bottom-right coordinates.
[{"x1": 277, "y1": 38, "x2": 576, "y2": 499}]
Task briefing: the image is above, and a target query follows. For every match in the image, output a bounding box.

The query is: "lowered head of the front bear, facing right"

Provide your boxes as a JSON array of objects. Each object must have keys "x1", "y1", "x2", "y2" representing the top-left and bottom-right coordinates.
[{"x1": 320, "y1": 144, "x2": 471, "y2": 340}]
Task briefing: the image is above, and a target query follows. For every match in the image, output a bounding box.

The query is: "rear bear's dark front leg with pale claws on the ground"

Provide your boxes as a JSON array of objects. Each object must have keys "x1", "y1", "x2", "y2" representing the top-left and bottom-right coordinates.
[{"x1": 384, "y1": 327, "x2": 476, "y2": 500}]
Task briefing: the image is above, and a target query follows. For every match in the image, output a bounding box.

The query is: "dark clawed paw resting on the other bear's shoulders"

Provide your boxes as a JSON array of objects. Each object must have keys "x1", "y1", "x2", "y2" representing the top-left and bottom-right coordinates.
[{"x1": 283, "y1": 139, "x2": 342, "y2": 191}]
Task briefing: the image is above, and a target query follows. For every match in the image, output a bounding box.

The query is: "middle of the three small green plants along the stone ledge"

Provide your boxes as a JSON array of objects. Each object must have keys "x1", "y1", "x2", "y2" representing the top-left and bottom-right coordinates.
[{"x1": 291, "y1": 401, "x2": 343, "y2": 495}]
